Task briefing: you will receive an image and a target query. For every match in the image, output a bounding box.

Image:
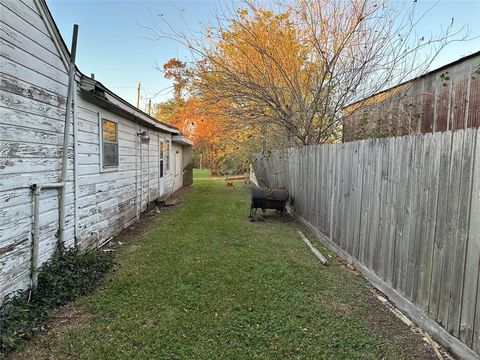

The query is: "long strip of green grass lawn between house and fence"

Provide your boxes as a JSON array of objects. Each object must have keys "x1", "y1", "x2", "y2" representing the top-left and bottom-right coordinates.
[{"x1": 14, "y1": 171, "x2": 431, "y2": 359}]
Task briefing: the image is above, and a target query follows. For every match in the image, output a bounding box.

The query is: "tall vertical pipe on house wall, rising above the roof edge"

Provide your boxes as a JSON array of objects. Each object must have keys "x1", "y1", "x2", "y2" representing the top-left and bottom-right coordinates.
[{"x1": 58, "y1": 24, "x2": 78, "y2": 254}]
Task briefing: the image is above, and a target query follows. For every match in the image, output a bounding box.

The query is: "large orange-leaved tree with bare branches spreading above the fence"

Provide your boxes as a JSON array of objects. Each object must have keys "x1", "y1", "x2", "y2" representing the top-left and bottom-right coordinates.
[{"x1": 151, "y1": 0, "x2": 467, "y2": 146}]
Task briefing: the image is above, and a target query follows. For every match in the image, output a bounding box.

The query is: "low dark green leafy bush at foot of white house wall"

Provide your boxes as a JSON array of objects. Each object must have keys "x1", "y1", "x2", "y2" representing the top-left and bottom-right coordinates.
[{"x1": 0, "y1": 249, "x2": 113, "y2": 353}]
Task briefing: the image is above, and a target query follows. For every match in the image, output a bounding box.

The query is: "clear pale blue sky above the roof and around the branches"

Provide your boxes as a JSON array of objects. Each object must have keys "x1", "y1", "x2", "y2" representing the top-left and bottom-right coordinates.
[{"x1": 47, "y1": 0, "x2": 480, "y2": 110}]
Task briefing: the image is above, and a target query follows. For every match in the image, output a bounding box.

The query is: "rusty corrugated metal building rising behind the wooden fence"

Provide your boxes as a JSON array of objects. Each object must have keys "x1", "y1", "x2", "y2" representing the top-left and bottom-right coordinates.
[{"x1": 344, "y1": 51, "x2": 480, "y2": 141}]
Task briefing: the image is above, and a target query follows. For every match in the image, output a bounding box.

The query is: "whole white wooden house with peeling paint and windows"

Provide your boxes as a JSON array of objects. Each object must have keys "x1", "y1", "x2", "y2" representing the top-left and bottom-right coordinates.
[{"x1": 0, "y1": 0, "x2": 192, "y2": 302}]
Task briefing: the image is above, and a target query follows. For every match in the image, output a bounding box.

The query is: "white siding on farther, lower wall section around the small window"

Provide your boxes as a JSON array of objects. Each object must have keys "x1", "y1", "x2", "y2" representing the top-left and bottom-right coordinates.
[{"x1": 77, "y1": 95, "x2": 176, "y2": 246}]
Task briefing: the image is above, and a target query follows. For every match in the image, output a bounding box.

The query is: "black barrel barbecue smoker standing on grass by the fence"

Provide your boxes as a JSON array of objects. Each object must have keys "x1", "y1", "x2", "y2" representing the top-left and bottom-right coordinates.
[{"x1": 250, "y1": 187, "x2": 289, "y2": 221}]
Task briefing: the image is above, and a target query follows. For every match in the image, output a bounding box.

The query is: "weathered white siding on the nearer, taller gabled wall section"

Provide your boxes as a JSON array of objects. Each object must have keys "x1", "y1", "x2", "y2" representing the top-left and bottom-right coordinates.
[{"x1": 0, "y1": 0, "x2": 74, "y2": 301}]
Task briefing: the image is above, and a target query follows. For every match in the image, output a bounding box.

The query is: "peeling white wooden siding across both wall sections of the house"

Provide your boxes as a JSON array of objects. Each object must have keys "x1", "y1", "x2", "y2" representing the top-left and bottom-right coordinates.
[{"x1": 0, "y1": 0, "x2": 184, "y2": 303}]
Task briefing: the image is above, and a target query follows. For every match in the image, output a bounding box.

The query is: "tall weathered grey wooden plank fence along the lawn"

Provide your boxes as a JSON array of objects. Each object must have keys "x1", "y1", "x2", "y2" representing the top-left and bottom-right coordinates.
[{"x1": 253, "y1": 129, "x2": 480, "y2": 358}]
